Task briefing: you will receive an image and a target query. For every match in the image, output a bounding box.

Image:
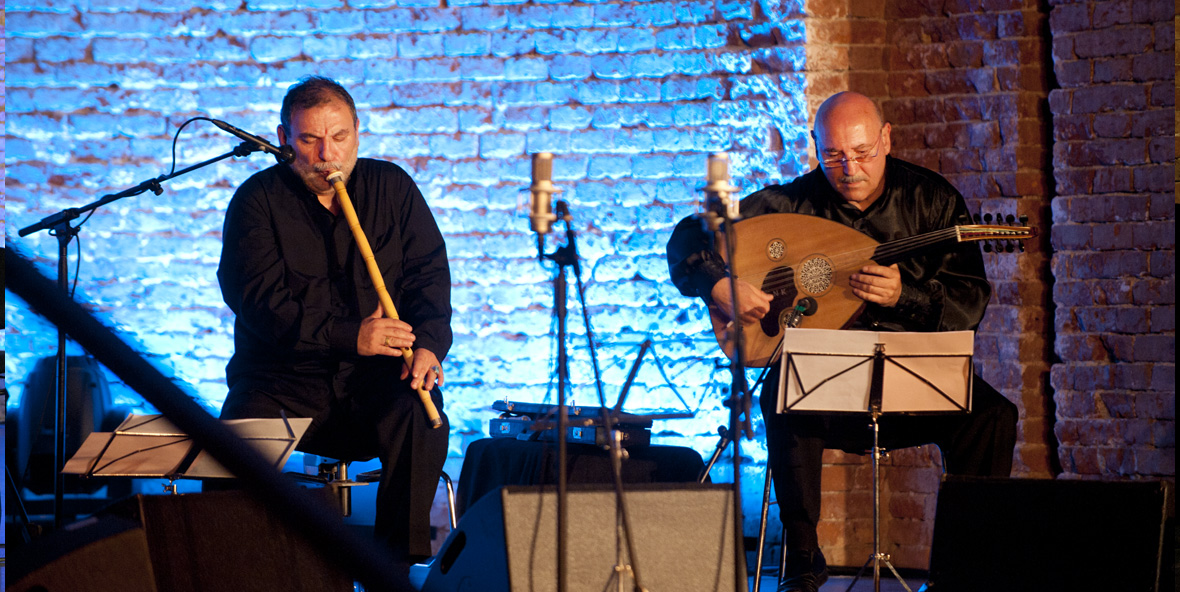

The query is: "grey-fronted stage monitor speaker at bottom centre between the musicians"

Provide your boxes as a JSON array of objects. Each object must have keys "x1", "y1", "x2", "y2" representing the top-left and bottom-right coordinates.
[{"x1": 422, "y1": 484, "x2": 747, "y2": 592}]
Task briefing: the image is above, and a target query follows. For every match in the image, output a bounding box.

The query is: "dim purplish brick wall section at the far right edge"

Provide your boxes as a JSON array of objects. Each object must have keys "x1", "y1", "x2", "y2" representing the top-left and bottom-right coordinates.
[{"x1": 1050, "y1": 1, "x2": 1175, "y2": 480}]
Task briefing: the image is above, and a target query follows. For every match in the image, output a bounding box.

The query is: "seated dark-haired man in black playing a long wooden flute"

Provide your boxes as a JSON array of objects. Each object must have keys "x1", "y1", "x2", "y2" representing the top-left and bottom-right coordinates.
[{"x1": 217, "y1": 77, "x2": 452, "y2": 566}]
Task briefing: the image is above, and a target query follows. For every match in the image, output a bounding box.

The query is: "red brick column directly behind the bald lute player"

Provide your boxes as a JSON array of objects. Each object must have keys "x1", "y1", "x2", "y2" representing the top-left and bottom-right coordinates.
[{"x1": 806, "y1": 0, "x2": 1054, "y2": 567}]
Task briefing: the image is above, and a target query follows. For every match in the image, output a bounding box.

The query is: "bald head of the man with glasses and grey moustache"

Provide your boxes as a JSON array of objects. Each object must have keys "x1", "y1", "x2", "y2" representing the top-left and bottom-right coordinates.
[{"x1": 812, "y1": 92, "x2": 891, "y2": 210}]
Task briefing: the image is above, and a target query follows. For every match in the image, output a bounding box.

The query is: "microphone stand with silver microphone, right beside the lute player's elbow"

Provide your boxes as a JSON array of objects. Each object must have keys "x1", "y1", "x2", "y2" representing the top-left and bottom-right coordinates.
[{"x1": 700, "y1": 158, "x2": 756, "y2": 592}]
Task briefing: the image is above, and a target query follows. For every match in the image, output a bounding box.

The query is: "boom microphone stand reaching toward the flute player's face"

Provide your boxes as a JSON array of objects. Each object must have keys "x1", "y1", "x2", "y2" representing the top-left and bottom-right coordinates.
[{"x1": 17, "y1": 142, "x2": 273, "y2": 529}]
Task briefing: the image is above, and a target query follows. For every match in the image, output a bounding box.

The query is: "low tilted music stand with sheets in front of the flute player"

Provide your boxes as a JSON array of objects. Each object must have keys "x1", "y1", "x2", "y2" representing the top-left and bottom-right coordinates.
[{"x1": 61, "y1": 414, "x2": 312, "y2": 493}]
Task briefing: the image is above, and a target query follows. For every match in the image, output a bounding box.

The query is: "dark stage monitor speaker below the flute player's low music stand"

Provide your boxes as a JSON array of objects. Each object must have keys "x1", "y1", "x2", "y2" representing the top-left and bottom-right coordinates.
[{"x1": 111, "y1": 491, "x2": 353, "y2": 592}]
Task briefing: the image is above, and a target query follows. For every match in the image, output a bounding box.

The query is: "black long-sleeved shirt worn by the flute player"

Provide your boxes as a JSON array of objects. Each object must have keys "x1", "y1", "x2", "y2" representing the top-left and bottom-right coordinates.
[{"x1": 217, "y1": 158, "x2": 452, "y2": 388}]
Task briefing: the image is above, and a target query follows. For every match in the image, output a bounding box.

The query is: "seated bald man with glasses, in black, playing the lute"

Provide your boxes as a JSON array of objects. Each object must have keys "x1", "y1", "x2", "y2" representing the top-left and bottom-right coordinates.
[{"x1": 668, "y1": 92, "x2": 1017, "y2": 592}]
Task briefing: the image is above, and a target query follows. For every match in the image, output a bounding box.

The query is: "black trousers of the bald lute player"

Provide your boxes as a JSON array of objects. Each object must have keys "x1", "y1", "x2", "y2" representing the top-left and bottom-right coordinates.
[{"x1": 760, "y1": 371, "x2": 1017, "y2": 552}]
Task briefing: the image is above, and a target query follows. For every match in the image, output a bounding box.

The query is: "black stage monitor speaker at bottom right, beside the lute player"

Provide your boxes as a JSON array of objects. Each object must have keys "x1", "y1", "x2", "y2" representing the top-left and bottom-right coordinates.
[{"x1": 930, "y1": 478, "x2": 1167, "y2": 592}]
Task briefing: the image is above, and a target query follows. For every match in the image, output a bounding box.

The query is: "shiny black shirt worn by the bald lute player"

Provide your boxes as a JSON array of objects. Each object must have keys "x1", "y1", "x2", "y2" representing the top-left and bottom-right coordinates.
[{"x1": 668, "y1": 157, "x2": 991, "y2": 331}]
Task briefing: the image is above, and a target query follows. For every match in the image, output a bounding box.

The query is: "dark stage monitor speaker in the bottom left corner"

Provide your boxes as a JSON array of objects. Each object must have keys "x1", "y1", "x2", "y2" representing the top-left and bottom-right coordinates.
[{"x1": 7, "y1": 517, "x2": 158, "y2": 592}]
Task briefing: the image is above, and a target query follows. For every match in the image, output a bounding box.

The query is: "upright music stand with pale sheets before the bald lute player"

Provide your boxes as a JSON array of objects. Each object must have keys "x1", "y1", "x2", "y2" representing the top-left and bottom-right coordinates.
[{"x1": 778, "y1": 329, "x2": 975, "y2": 592}]
